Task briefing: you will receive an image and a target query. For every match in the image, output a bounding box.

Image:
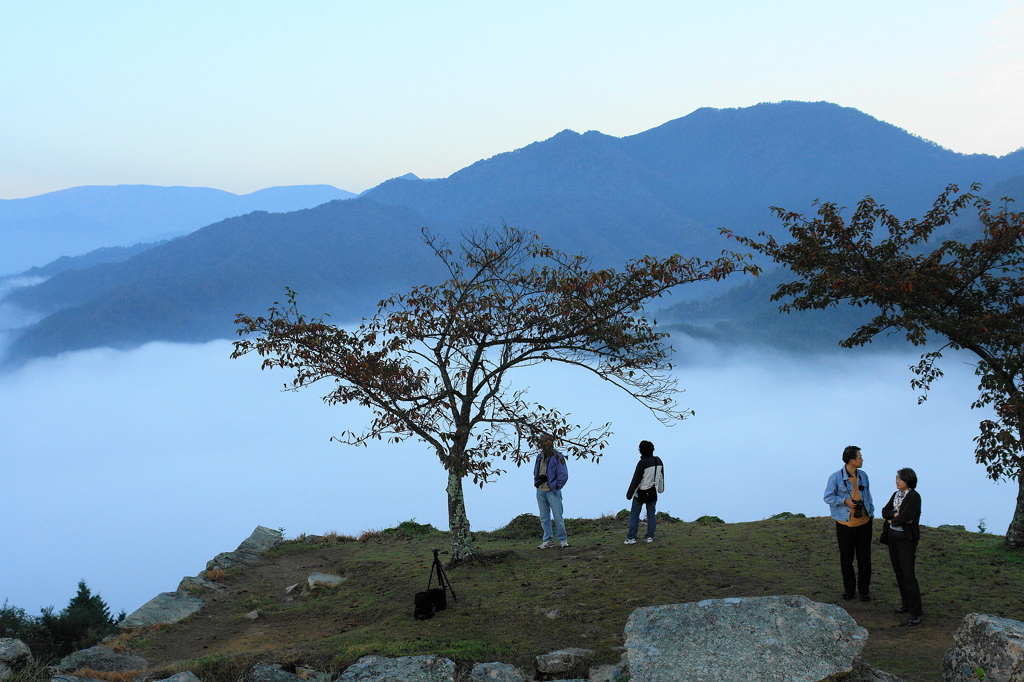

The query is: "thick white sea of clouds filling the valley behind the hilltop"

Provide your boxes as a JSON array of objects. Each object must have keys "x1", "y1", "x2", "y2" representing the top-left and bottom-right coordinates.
[{"x1": 0, "y1": 341, "x2": 1016, "y2": 613}]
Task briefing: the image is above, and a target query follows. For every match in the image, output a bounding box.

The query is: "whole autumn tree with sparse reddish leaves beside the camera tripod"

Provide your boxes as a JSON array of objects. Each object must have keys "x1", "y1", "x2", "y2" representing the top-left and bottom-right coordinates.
[{"x1": 232, "y1": 226, "x2": 756, "y2": 559}]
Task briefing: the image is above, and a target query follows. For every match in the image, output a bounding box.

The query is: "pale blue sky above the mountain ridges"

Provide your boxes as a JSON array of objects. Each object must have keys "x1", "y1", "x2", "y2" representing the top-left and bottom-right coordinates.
[{"x1": 0, "y1": 0, "x2": 1024, "y2": 199}]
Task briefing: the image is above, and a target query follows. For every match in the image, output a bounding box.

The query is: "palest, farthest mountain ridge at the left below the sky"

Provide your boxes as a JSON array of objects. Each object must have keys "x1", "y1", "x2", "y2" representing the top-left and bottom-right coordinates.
[{"x1": 0, "y1": 184, "x2": 356, "y2": 275}]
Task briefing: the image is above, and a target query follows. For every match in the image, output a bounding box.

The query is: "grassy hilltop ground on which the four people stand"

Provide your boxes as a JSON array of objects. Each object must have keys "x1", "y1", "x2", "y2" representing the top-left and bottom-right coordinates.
[{"x1": 92, "y1": 512, "x2": 1024, "y2": 682}]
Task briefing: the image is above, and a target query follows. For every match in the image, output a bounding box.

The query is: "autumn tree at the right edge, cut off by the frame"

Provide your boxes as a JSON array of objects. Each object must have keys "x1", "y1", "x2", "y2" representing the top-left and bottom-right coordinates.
[{"x1": 723, "y1": 185, "x2": 1024, "y2": 549}]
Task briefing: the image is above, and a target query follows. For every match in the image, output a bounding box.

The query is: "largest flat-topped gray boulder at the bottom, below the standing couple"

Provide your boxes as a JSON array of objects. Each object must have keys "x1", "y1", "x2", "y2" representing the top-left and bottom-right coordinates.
[{"x1": 626, "y1": 595, "x2": 867, "y2": 682}]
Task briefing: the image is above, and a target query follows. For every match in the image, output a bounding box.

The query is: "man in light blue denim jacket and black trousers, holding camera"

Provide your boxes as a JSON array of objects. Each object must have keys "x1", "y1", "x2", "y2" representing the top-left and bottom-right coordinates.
[{"x1": 824, "y1": 445, "x2": 874, "y2": 601}]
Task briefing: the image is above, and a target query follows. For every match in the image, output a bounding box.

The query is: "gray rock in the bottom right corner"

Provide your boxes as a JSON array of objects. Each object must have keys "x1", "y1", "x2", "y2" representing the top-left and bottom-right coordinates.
[{"x1": 942, "y1": 613, "x2": 1024, "y2": 682}]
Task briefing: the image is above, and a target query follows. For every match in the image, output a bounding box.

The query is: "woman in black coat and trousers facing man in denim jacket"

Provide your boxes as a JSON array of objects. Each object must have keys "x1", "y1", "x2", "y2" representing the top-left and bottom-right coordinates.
[{"x1": 882, "y1": 469, "x2": 922, "y2": 626}]
